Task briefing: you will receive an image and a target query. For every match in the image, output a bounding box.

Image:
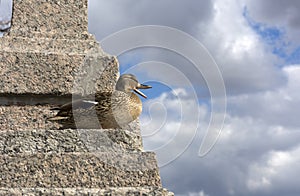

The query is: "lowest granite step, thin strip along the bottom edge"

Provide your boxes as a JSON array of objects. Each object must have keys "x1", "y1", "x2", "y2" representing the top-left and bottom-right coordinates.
[{"x1": 0, "y1": 187, "x2": 174, "y2": 196}]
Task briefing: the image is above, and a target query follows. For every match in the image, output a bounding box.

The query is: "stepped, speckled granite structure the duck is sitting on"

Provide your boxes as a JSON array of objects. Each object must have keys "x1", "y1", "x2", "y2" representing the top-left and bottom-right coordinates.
[{"x1": 0, "y1": 0, "x2": 172, "y2": 195}]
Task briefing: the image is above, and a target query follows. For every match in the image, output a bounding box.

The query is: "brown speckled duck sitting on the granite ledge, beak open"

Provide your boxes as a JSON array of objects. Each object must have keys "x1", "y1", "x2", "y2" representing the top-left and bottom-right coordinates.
[{"x1": 48, "y1": 74, "x2": 151, "y2": 129}]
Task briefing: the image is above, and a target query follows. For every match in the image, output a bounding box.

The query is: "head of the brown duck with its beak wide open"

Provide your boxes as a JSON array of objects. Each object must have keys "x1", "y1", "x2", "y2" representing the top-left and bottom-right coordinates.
[{"x1": 116, "y1": 74, "x2": 152, "y2": 98}]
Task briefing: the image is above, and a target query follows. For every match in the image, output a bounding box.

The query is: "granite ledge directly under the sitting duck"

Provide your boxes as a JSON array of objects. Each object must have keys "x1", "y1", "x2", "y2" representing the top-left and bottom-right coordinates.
[{"x1": 0, "y1": 129, "x2": 142, "y2": 155}]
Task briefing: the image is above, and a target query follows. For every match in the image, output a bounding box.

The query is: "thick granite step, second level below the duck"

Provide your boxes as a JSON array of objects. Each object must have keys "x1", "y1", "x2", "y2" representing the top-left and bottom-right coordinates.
[{"x1": 0, "y1": 152, "x2": 161, "y2": 188}]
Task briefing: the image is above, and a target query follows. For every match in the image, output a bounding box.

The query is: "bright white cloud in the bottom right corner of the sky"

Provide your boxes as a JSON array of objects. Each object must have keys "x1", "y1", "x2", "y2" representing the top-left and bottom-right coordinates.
[{"x1": 247, "y1": 146, "x2": 300, "y2": 195}]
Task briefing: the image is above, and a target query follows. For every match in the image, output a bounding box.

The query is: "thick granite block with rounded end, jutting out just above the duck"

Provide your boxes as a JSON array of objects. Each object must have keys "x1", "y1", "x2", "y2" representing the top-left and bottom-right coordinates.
[{"x1": 0, "y1": 48, "x2": 119, "y2": 95}]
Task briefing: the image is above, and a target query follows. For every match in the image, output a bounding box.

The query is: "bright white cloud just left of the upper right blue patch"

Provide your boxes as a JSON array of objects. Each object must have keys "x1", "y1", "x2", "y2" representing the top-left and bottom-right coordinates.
[{"x1": 199, "y1": 0, "x2": 284, "y2": 93}]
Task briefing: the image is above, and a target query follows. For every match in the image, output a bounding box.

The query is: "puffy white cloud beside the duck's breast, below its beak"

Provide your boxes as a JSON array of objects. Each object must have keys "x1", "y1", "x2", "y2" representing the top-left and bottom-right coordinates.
[{"x1": 140, "y1": 88, "x2": 209, "y2": 161}]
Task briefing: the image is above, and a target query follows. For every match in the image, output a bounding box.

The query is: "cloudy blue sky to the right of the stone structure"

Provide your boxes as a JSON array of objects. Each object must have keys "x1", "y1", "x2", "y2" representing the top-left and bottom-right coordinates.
[{"x1": 89, "y1": 0, "x2": 300, "y2": 196}]
